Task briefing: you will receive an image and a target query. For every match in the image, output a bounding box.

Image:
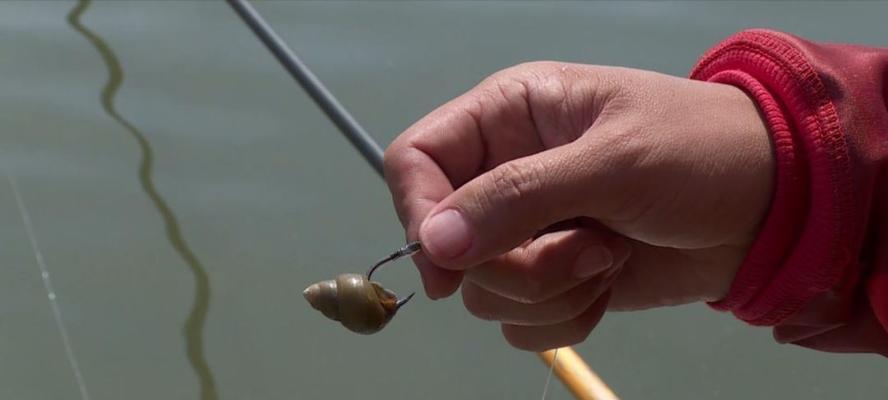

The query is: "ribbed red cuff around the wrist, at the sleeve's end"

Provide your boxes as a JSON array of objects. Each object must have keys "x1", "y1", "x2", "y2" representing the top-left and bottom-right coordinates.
[{"x1": 691, "y1": 30, "x2": 862, "y2": 325}]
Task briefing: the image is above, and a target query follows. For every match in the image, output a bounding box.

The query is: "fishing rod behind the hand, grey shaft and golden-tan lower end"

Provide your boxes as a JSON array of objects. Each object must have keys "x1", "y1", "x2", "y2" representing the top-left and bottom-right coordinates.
[{"x1": 226, "y1": 0, "x2": 617, "y2": 400}]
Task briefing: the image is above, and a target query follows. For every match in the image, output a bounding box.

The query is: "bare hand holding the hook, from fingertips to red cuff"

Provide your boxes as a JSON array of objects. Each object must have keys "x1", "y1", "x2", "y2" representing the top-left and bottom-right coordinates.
[{"x1": 385, "y1": 62, "x2": 774, "y2": 351}]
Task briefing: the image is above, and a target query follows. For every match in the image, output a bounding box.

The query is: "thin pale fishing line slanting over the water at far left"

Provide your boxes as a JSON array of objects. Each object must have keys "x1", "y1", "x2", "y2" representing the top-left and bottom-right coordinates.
[{"x1": 4, "y1": 171, "x2": 90, "y2": 400}]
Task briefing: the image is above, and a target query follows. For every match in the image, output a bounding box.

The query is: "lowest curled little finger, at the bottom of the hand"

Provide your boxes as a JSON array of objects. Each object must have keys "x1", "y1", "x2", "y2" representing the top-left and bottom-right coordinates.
[{"x1": 502, "y1": 292, "x2": 610, "y2": 351}]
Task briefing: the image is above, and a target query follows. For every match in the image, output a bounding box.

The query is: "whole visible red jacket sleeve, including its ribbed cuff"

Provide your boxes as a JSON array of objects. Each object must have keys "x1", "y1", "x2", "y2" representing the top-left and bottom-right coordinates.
[{"x1": 691, "y1": 30, "x2": 888, "y2": 356}]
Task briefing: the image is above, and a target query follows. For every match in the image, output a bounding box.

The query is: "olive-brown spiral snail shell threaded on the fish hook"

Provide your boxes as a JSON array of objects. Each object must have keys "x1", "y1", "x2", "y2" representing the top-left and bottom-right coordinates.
[{"x1": 302, "y1": 274, "x2": 398, "y2": 335}]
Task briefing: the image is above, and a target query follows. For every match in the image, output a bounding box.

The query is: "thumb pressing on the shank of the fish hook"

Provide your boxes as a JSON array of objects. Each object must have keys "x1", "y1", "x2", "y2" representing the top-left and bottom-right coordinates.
[{"x1": 419, "y1": 141, "x2": 616, "y2": 270}]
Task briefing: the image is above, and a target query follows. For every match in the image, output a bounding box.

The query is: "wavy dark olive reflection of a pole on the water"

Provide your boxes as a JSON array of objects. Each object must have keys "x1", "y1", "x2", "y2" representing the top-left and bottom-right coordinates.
[{"x1": 68, "y1": 0, "x2": 218, "y2": 400}]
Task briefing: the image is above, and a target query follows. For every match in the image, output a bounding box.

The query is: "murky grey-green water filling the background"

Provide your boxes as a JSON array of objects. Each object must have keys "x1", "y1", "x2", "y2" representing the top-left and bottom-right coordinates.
[{"x1": 0, "y1": 1, "x2": 888, "y2": 399}]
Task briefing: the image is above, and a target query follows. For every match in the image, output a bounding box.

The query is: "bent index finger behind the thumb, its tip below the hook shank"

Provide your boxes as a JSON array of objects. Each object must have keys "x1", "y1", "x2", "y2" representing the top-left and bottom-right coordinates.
[{"x1": 384, "y1": 68, "x2": 541, "y2": 299}]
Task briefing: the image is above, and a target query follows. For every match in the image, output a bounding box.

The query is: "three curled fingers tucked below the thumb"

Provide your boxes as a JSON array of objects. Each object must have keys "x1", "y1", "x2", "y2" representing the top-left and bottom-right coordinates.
[{"x1": 454, "y1": 228, "x2": 630, "y2": 351}]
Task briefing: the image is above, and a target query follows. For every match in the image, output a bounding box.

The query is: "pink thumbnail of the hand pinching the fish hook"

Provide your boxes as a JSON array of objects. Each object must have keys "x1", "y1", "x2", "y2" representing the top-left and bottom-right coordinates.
[{"x1": 420, "y1": 208, "x2": 472, "y2": 259}]
